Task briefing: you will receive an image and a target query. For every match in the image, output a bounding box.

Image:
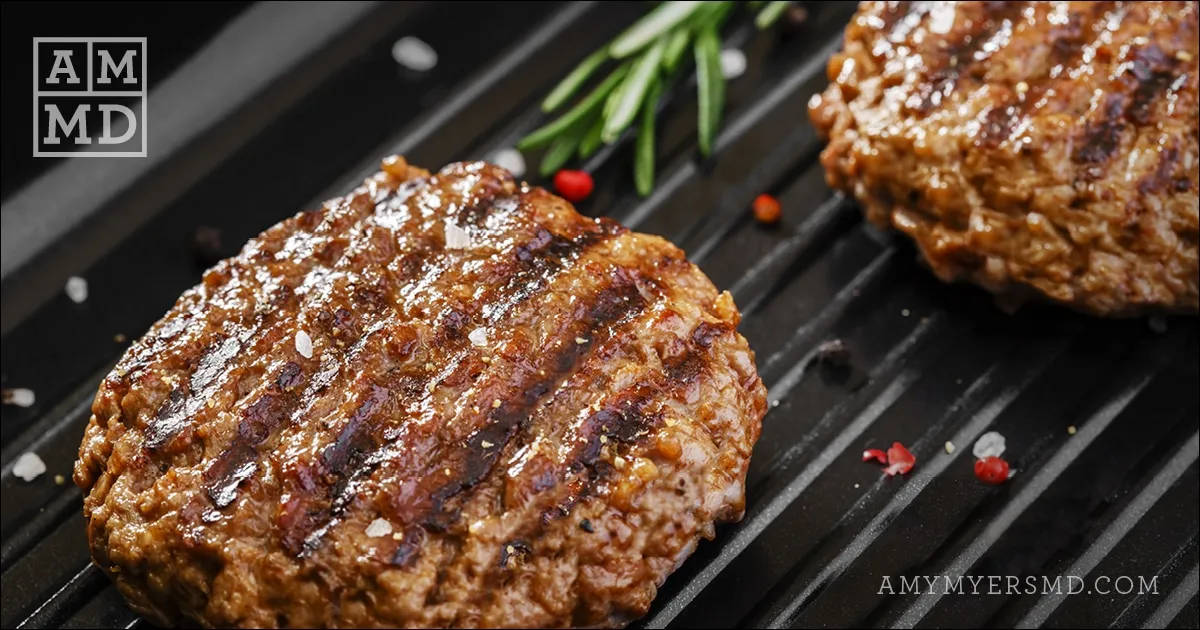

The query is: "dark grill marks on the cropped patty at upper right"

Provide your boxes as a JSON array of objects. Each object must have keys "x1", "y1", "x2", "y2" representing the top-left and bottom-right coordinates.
[{"x1": 881, "y1": 2, "x2": 1184, "y2": 180}]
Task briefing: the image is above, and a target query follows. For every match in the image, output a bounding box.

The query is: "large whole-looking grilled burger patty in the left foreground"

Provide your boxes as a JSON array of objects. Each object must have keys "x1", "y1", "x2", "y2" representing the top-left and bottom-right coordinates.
[{"x1": 74, "y1": 158, "x2": 766, "y2": 628}]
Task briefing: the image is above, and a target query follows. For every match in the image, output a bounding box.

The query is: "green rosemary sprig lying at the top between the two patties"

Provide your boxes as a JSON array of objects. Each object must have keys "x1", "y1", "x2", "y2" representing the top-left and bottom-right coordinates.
[{"x1": 517, "y1": 0, "x2": 791, "y2": 196}]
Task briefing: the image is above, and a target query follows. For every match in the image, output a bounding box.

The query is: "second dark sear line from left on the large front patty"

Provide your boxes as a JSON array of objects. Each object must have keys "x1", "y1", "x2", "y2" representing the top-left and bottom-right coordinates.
[{"x1": 204, "y1": 361, "x2": 304, "y2": 508}]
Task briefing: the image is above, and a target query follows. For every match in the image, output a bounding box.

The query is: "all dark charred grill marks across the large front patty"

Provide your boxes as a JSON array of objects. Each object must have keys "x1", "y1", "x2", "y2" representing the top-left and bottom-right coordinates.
[{"x1": 131, "y1": 156, "x2": 727, "y2": 565}]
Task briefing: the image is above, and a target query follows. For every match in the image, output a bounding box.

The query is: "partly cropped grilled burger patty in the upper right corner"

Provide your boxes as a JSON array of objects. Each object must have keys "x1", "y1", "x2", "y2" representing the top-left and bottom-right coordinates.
[{"x1": 810, "y1": 2, "x2": 1200, "y2": 316}]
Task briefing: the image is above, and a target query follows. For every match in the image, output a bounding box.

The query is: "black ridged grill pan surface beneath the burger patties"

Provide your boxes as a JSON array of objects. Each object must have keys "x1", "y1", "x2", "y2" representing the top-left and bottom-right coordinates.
[{"x1": 0, "y1": 2, "x2": 1200, "y2": 628}]
